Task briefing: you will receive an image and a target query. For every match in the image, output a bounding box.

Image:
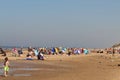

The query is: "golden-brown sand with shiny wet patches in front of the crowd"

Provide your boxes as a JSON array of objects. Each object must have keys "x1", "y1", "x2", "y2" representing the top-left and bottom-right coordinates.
[{"x1": 0, "y1": 53, "x2": 120, "y2": 80}]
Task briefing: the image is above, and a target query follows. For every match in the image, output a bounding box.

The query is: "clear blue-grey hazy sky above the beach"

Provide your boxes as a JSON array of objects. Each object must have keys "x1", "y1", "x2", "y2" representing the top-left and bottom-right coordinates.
[{"x1": 0, "y1": 0, "x2": 120, "y2": 48}]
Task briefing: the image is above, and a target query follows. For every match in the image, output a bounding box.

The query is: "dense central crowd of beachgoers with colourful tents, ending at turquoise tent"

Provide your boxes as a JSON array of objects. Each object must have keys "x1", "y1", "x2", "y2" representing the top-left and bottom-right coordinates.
[{"x1": 24, "y1": 46, "x2": 89, "y2": 60}]
